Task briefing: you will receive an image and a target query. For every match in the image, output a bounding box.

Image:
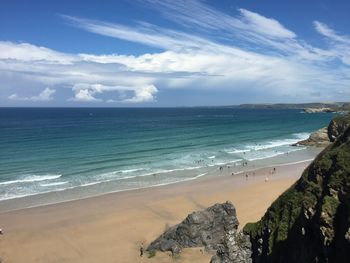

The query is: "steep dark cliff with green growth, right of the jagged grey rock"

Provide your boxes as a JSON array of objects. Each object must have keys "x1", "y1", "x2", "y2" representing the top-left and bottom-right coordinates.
[{"x1": 244, "y1": 128, "x2": 350, "y2": 263}]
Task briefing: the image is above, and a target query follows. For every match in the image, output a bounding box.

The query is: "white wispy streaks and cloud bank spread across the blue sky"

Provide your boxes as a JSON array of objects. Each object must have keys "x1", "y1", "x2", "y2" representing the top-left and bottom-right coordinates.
[{"x1": 0, "y1": 0, "x2": 350, "y2": 103}]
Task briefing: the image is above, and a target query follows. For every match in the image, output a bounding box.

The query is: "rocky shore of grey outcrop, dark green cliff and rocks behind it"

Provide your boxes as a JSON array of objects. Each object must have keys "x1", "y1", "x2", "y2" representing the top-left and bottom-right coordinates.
[{"x1": 147, "y1": 115, "x2": 350, "y2": 263}]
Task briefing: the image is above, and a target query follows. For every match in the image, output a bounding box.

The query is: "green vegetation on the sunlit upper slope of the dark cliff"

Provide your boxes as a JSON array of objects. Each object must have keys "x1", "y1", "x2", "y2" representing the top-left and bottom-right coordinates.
[{"x1": 243, "y1": 128, "x2": 350, "y2": 254}]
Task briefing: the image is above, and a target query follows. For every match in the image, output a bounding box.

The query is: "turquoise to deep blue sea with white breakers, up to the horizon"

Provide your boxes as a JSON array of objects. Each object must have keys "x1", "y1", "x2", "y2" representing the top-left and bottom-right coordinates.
[{"x1": 0, "y1": 107, "x2": 333, "y2": 212}]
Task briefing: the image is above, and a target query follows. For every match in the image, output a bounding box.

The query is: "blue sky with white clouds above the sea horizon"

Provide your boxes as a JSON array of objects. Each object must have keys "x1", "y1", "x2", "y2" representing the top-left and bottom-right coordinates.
[{"x1": 0, "y1": 0, "x2": 350, "y2": 107}]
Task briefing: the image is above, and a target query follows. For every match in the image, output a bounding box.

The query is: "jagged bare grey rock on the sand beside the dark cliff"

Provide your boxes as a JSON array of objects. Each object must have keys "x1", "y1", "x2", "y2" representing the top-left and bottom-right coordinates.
[{"x1": 147, "y1": 202, "x2": 251, "y2": 263}]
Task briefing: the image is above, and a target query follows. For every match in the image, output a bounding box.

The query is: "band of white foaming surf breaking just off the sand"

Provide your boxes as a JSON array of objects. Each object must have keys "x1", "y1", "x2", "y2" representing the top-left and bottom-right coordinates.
[{"x1": 0, "y1": 133, "x2": 309, "y2": 200}]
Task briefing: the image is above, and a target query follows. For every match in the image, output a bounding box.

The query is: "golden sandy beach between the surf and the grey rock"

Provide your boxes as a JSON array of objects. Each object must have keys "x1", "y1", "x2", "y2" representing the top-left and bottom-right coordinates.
[{"x1": 0, "y1": 161, "x2": 310, "y2": 263}]
